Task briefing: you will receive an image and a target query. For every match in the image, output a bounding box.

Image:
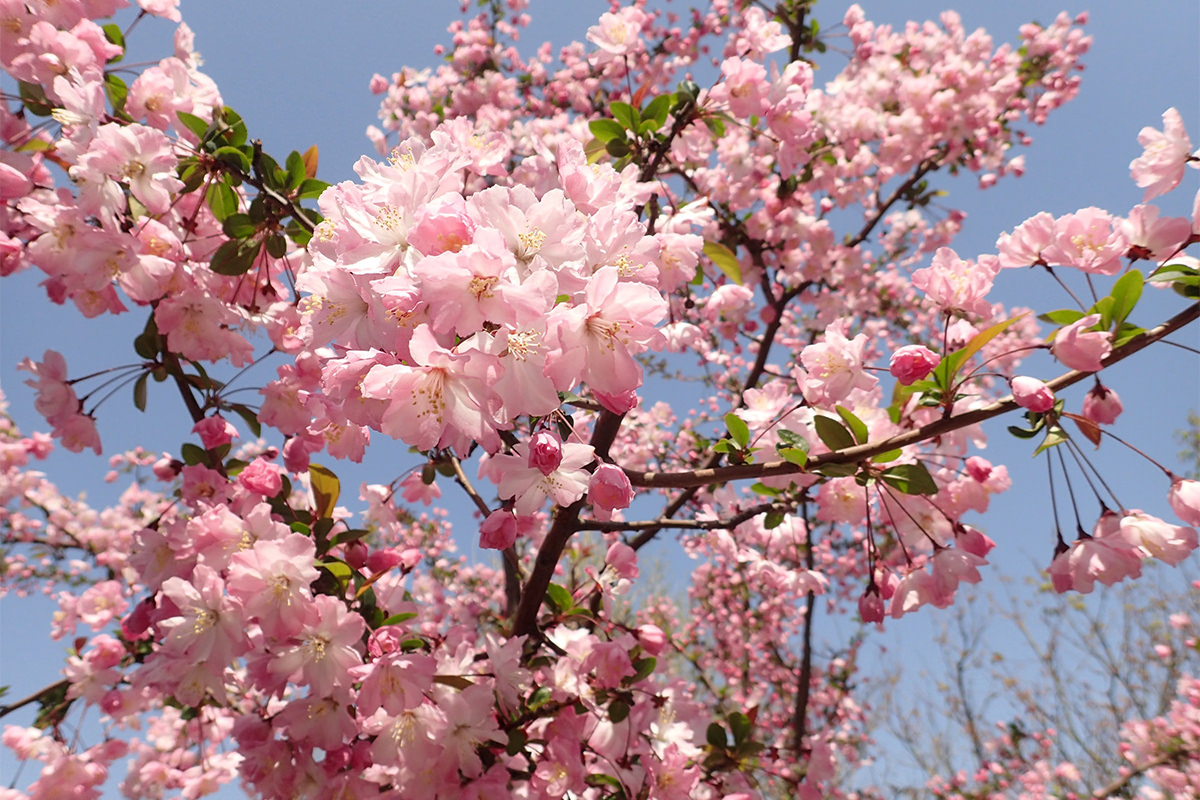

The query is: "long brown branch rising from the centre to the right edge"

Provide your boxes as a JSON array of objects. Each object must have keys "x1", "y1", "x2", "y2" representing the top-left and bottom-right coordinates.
[{"x1": 625, "y1": 305, "x2": 1200, "y2": 488}]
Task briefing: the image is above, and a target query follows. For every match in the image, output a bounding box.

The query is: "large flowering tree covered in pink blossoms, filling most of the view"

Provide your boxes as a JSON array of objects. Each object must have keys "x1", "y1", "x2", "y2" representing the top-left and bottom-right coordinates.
[{"x1": 0, "y1": 0, "x2": 1200, "y2": 799}]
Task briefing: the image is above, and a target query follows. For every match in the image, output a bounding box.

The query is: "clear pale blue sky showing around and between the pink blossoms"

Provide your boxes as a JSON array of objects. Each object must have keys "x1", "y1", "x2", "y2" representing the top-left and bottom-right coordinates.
[{"x1": 0, "y1": 0, "x2": 1200, "y2": 796}]
